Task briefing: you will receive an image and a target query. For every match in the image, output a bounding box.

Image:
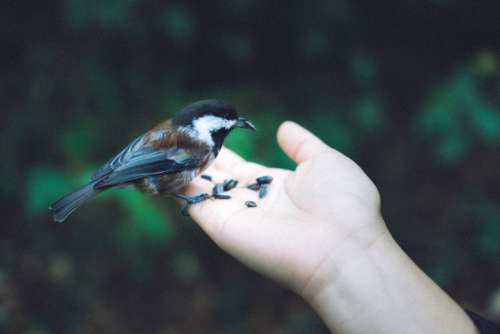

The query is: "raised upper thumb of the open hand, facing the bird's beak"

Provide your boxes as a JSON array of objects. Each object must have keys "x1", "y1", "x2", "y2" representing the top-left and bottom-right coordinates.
[{"x1": 277, "y1": 121, "x2": 331, "y2": 164}]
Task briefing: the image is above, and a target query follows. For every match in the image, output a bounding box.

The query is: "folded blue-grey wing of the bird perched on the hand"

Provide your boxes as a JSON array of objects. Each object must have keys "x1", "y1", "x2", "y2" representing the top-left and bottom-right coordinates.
[{"x1": 95, "y1": 146, "x2": 202, "y2": 189}]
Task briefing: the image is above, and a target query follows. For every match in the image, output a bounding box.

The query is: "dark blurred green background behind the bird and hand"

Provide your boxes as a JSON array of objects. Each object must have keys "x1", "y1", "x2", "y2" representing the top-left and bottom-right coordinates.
[{"x1": 0, "y1": 0, "x2": 500, "y2": 334}]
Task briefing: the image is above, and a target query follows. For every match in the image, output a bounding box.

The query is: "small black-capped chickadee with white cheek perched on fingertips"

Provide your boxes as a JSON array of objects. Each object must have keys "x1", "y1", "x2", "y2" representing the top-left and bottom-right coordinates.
[{"x1": 49, "y1": 100, "x2": 255, "y2": 222}]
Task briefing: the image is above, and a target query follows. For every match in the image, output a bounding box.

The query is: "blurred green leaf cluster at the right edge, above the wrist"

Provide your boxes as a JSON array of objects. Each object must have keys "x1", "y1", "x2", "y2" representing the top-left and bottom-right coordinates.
[{"x1": 418, "y1": 65, "x2": 500, "y2": 164}]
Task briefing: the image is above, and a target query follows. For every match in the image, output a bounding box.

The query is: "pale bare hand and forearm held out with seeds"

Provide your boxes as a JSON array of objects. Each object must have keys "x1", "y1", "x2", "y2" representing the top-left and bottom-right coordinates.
[{"x1": 183, "y1": 122, "x2": 477, "y2": 334}]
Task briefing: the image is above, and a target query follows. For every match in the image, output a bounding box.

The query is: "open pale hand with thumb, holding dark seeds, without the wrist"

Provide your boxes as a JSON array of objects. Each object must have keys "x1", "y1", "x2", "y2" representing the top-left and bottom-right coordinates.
[{"x1": 187, "y1": 122, "x2": 387, "y2": 294}]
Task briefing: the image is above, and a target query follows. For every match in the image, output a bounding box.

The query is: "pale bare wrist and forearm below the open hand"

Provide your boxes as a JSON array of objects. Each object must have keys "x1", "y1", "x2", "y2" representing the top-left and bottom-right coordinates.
[{"x1": 304, "y1": 224, "x2": 476, "y2": 333}]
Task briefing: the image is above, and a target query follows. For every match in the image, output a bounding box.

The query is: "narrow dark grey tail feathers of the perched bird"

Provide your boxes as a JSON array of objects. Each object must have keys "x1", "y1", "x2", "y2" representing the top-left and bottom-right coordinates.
[{"x1": 49, "y1": 182, "x2": 99, "y2": 223}]
